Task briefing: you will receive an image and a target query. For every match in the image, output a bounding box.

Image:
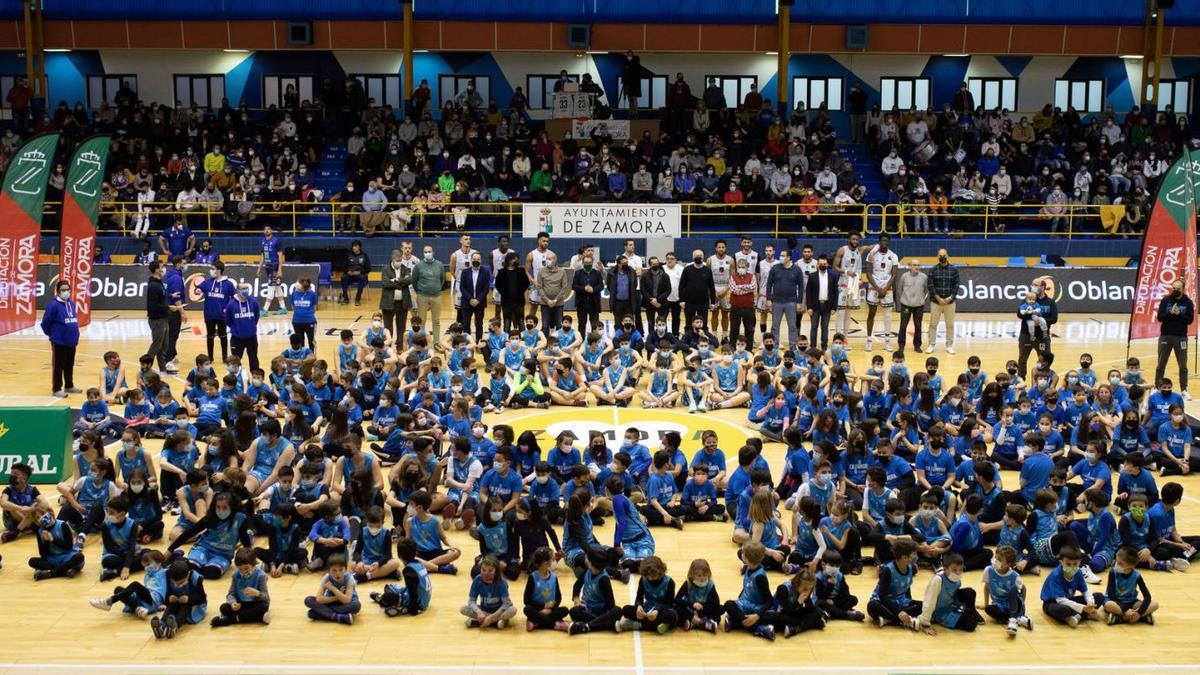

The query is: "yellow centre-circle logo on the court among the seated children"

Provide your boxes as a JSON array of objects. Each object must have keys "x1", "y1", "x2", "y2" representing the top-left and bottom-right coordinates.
[{"x1": 504, "y1": 407, "x2": 750, "y2": 456}]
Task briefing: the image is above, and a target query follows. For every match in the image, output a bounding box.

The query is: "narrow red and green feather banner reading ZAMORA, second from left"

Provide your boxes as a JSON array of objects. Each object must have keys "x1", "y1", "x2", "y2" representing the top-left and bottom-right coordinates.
[{"x1": 59, "y1": 136, "x2": 109, "y2": 328}]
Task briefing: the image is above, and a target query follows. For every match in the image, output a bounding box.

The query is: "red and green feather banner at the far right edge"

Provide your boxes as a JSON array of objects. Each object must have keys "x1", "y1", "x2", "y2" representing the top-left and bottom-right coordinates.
[{"x1": 1129, "y1": 145, "x2": 1200, "y2": 340}]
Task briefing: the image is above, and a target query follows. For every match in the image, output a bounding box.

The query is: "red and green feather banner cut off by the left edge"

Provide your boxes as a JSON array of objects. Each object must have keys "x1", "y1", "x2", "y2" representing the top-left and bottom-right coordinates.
[{"x1": 0, "y1": 133, "x2": 59, "y2": 335}]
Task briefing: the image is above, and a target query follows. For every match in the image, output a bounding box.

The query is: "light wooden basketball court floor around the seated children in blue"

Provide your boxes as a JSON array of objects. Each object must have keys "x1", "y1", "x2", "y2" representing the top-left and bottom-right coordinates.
[{"x1": 0, "y1": 298, "x2": 1200, "y2": 673}]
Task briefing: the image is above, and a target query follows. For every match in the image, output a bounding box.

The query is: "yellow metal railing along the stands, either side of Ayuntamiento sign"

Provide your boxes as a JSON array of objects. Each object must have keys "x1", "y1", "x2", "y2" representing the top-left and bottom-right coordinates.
[{"x1": 43, "y1": 202, "x2": 1123, "y2": 238}]
